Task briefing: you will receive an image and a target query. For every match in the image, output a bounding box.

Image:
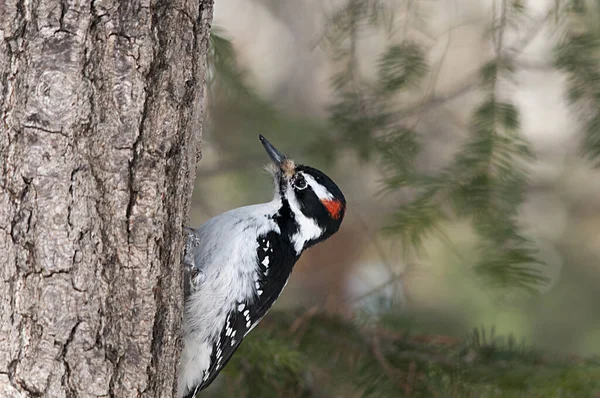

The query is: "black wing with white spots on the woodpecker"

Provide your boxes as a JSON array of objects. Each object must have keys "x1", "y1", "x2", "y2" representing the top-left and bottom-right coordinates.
[{"x1": 186, "y1": 232, "x2": 298, "y2": 398}]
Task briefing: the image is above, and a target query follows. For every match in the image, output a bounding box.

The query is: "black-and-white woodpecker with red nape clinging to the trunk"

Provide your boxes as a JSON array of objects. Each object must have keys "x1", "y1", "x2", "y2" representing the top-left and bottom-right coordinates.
[{"x1": 178, "y1": 135, "x2": 346, "y2": 398}]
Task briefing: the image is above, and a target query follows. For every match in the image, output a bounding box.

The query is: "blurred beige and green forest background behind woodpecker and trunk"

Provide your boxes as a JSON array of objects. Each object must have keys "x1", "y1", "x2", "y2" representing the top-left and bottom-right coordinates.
[{"x1": 192, "y1": 0, "x2": 600, "y2": 397}]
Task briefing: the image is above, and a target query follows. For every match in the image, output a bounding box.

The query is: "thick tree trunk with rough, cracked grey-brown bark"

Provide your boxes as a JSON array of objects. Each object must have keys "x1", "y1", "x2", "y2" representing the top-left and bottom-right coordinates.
[{"x1": 0, "y1": 0, "x2": 212, "y2": 398}]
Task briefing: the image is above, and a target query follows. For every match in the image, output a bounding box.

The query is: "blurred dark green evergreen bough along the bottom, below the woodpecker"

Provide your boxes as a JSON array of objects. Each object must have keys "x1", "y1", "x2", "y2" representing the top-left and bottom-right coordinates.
[{"x1": 206, "y1": 310, "x2": 600, "y2": 398}]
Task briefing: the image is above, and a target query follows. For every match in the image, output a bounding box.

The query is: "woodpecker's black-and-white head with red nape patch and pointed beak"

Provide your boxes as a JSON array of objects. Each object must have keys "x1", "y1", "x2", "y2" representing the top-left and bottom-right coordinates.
[{"x1": 259, "y1": 135, "x2": 346, "y2": 254}]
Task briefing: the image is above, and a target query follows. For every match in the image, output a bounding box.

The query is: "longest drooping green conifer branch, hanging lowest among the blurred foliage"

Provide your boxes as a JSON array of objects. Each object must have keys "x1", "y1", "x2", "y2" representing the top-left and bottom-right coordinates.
[{"x1": 382, "y1": 0, "x2": 546, "y2": 291}]
